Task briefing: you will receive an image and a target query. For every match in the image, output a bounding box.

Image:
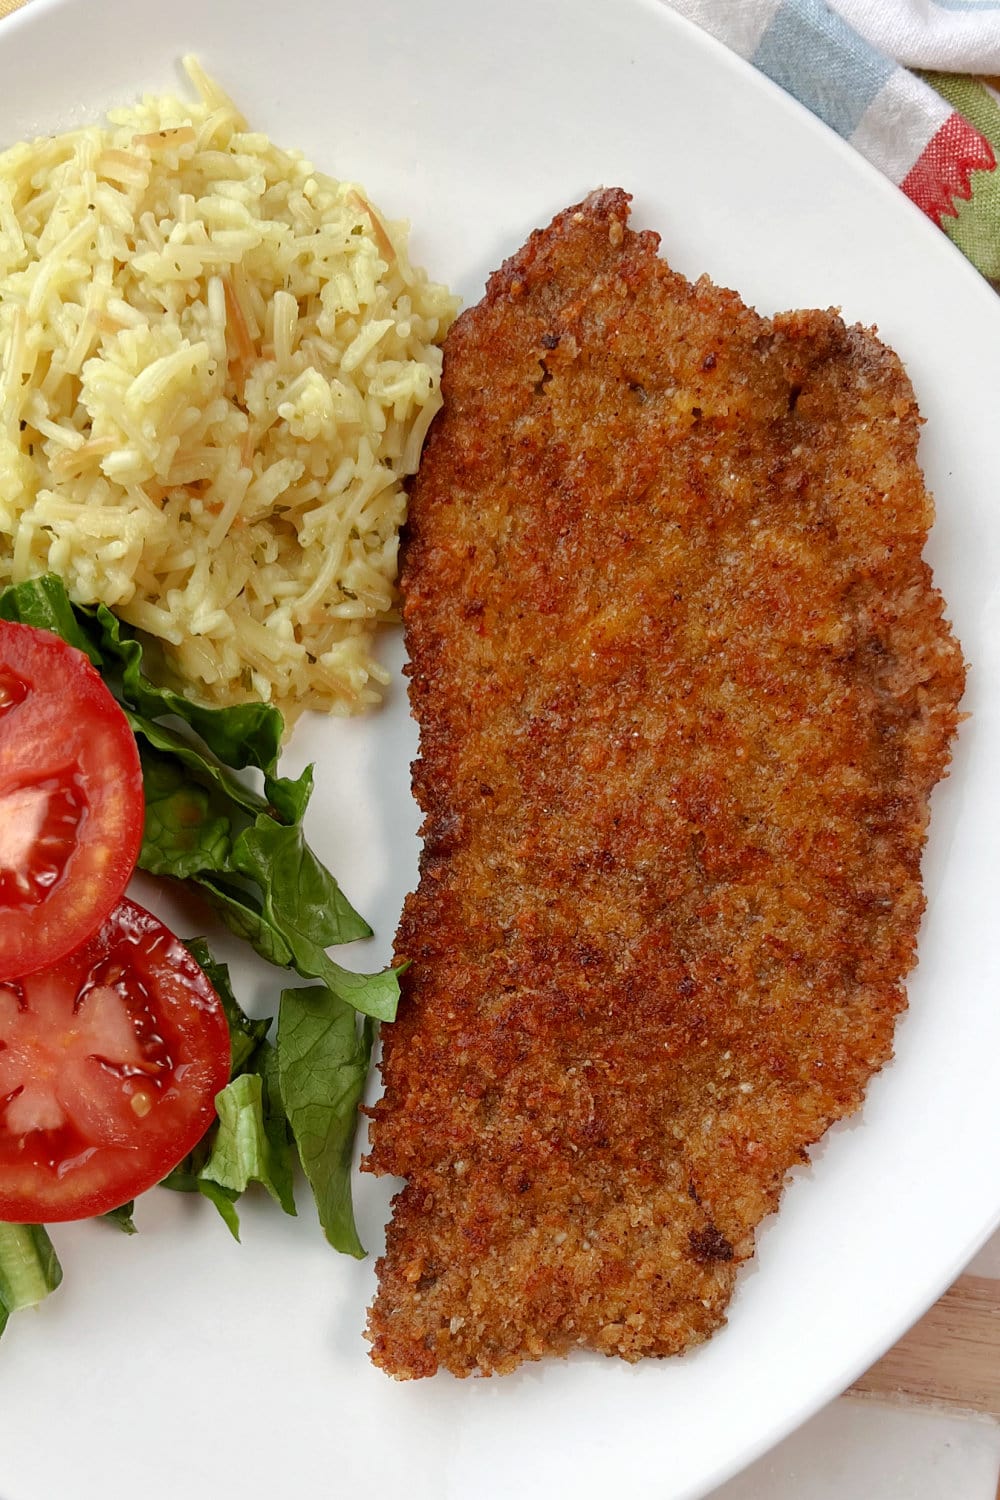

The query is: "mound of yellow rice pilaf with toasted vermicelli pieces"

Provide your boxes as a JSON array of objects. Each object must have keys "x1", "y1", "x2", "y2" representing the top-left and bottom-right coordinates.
[{"x1": 0, "y1": 69, "x2": 456, "y2": 717}]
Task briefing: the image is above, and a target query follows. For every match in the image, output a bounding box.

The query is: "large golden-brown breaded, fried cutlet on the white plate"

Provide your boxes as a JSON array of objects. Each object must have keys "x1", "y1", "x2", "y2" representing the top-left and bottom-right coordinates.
[{"x1": 367, "y1": 191, "x2": 964, "y2": 1379}]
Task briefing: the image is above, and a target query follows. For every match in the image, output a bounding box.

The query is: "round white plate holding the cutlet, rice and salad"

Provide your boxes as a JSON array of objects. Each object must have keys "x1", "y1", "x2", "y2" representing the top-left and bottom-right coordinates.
[{"x1": 0, "y1": 0, "x2": 1000, "y2": 1500}]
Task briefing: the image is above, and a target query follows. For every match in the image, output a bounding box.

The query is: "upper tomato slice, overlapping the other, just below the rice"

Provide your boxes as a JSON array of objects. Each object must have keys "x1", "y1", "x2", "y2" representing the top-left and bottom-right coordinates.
[{"x1": 0, "y1": 620, "x2": 144, "y2": 980}]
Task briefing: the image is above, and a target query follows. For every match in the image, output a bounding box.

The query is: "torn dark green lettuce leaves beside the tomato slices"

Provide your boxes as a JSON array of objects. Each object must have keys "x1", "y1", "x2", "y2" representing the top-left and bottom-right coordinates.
[{"x1": 0, "y1": 575, "x2": 399, "y2": 1332}]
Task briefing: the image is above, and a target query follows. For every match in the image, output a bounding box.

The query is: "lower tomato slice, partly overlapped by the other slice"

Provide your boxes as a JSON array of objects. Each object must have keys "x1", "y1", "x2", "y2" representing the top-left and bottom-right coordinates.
[{"x1": 0, "y1": 900, "x2": 229, "y2": 1224}]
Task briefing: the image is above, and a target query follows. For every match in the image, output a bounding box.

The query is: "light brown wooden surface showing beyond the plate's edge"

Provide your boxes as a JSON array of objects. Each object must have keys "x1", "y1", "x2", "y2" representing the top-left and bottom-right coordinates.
[{"x1": 0, "y1": 0, "x2": 1000, "y2": 1428}]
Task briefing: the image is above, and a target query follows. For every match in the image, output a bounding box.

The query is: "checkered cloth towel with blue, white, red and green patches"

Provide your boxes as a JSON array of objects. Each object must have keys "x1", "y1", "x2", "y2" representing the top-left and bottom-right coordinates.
[{"x1": 667, "y1": 0, "x2": 1000, "y2": 281}]
